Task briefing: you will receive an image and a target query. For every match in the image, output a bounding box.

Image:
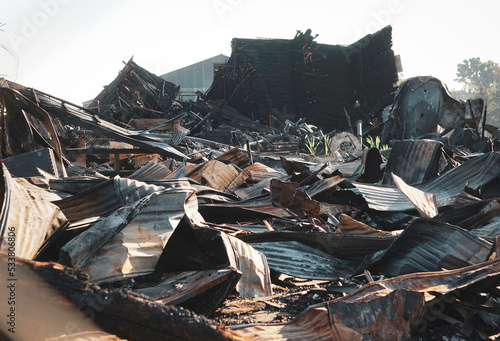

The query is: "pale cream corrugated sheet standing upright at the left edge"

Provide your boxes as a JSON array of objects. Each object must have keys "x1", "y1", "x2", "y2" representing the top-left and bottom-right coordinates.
[{"x1": 0, "y1": 163, "x2": 68, "y2": 259}]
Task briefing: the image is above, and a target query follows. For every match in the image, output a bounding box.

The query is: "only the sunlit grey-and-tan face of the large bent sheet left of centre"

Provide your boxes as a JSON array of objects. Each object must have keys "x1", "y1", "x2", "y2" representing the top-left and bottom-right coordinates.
[{"x1": 74, "y1": 187, "x2": 199, "y2": 283}]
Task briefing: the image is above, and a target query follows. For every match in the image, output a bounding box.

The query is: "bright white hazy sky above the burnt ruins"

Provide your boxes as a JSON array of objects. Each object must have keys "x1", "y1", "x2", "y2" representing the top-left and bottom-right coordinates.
[{"x1": 0, "y1": 0, "x2": 500, "y2": 103}]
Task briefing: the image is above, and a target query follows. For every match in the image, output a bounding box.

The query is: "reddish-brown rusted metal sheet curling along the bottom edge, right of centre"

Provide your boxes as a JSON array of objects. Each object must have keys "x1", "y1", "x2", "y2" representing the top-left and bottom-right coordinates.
[{"x1": 233, "y1": 290, "x2": 425, "y2": 341}]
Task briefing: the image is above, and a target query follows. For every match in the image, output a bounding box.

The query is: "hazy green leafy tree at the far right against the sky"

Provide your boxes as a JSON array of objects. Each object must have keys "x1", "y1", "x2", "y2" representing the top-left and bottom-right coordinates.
[{"x1": 455, "y1": 57, "x2": 500, "y2": 127}]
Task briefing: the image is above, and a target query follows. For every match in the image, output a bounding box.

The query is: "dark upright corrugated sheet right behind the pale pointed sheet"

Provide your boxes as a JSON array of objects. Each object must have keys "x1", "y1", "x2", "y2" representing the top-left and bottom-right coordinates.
[{"x1": 382, "y1": 140, "x2": 443, "y2": 185}]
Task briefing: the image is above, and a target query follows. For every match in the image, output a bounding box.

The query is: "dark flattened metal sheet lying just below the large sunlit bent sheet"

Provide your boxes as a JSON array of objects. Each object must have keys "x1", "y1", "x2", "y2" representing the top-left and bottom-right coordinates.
[{"x1": 135, "y1": 267, "x2": 241, "y2": 315}]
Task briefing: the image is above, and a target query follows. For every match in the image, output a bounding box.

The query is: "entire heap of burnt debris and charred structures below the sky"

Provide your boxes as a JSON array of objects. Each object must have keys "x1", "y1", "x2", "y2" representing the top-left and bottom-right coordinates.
[{"x1": 0, "y1": 27, "x2": 500, "y2": 341}]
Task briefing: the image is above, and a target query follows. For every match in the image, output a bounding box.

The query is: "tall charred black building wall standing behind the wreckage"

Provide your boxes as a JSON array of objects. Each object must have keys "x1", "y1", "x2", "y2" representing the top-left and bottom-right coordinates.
[{"x1": 206, "y1": 26, "x2": 398, "y2": 131}]
